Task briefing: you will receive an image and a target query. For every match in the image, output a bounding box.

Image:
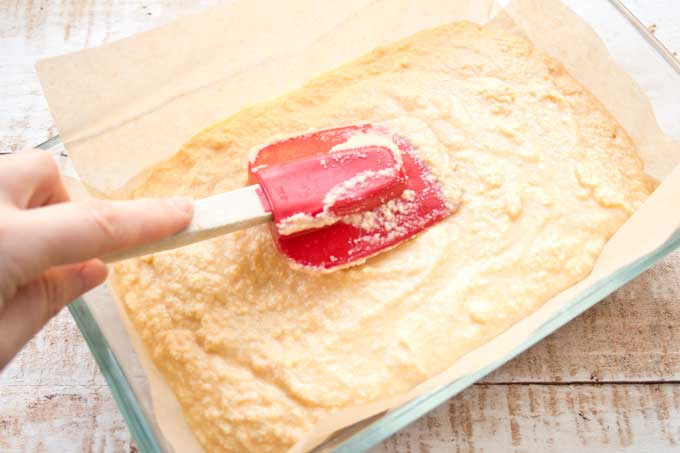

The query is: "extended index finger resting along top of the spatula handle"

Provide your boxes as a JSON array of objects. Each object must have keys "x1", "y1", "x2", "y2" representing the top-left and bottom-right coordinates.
[{"x1": 7, "y1": 198, "x2": 193, "y2": 277}]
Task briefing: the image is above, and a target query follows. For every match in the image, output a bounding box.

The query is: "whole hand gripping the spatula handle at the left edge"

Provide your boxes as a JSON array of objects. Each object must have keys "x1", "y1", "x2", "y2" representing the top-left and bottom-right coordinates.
[{"x1": 0, "y1": 150, "x2": 193, "y2": 370}]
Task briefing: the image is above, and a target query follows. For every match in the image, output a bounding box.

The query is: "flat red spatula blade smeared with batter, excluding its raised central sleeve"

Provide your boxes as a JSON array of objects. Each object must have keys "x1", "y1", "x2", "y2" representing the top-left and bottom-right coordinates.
[{"x1": 249, "y1": 124, "x2": 451, "y2": 271}]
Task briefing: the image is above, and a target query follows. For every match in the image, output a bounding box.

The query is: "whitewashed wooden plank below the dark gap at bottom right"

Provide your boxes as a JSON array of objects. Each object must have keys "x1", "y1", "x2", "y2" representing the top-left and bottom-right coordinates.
[{"x1": 373, "y1": 384, "x2": 680, "y2": 453}]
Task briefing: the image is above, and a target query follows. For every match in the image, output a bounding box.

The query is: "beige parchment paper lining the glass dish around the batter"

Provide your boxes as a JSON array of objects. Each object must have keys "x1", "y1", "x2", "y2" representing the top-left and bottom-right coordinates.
[{"x1": 38, "y1": 0, "x2": 680, "y2": 452}]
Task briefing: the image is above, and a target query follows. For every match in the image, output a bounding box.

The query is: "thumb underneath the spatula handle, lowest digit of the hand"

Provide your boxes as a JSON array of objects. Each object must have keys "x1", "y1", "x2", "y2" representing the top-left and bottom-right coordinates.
[{"x1": 0, "y1": 260, "x2": 107, "y2": 369}]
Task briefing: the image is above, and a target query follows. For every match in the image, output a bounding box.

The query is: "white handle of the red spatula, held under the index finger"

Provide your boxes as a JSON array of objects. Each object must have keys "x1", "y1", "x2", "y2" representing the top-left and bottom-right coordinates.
[{"x1": 102, "y1": 185, "x2": 272, "y2": 263}]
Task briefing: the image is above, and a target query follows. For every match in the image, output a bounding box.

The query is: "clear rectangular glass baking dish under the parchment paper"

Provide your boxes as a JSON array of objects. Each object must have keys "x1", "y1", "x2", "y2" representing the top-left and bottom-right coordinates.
[{"x1": 38, "y1": 0, "x2": 680, "y2": 452}]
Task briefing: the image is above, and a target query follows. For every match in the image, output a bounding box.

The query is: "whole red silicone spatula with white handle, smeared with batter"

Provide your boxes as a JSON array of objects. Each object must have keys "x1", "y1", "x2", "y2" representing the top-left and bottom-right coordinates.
[{"x1": 104, "y1": 125, "x2": 449, "y2": 271}]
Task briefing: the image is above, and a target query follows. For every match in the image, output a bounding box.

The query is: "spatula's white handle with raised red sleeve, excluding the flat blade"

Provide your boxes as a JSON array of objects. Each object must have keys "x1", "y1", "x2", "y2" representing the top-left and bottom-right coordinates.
[{"x1": 103, "y1": 140, "x2": 406, "y2": 262}]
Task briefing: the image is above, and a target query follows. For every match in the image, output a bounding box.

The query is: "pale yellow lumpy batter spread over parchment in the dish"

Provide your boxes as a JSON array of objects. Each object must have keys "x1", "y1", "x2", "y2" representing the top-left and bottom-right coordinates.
[{"x1": 111, "y1": 23, "x2": 652, "y2": 452}]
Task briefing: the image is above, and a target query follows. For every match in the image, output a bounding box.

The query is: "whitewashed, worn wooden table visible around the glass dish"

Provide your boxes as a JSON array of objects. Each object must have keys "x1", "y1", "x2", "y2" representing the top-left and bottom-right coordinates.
[{"x1": 0, "y1": 0, "x2": 680, "y2": 453}]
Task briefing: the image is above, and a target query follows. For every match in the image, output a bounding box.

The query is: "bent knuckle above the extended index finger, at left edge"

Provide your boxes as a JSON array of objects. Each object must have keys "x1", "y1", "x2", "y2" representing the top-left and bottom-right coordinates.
[{"x1": 0, "y1": 149, "x2": 69, "y2": 209}]
